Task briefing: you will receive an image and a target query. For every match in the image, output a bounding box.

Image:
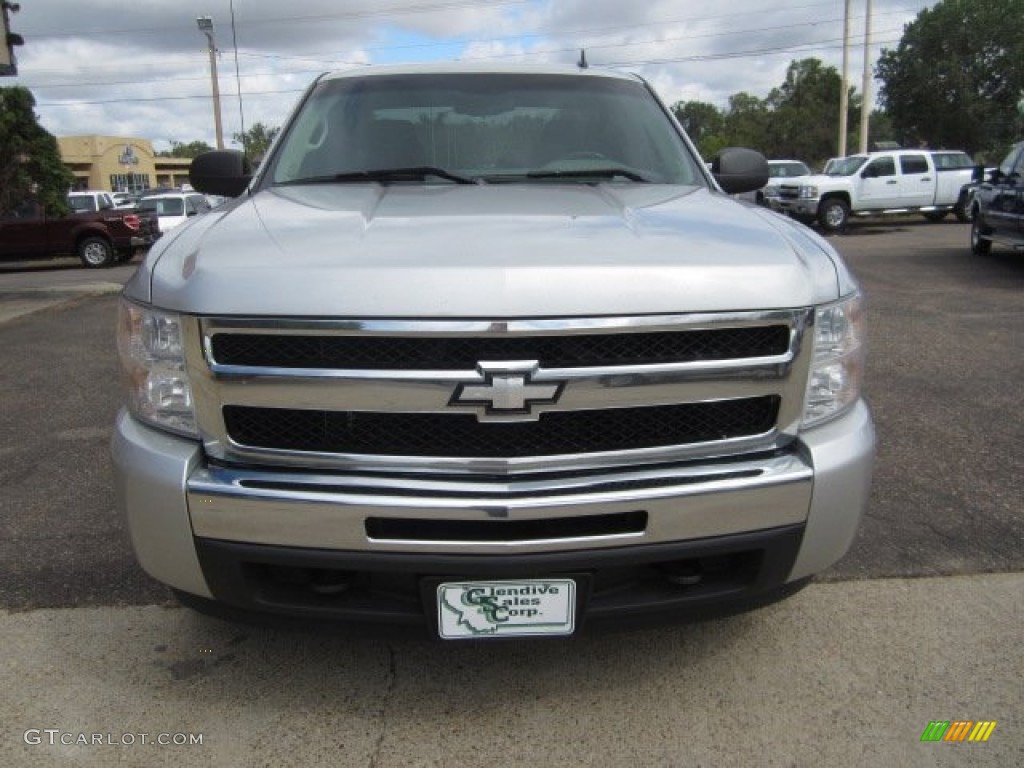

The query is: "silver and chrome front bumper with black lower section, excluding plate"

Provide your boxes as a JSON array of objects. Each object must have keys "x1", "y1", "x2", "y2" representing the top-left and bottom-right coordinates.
[{"x1": 114, "y1": 403, "x2": 874, "y2": 624}]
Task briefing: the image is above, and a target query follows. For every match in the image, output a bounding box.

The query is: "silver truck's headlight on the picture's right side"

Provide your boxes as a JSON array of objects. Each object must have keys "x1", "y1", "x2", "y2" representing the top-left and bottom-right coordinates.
[{"x1": 802, "y1": 294, "x2": 867, "y2": 427}]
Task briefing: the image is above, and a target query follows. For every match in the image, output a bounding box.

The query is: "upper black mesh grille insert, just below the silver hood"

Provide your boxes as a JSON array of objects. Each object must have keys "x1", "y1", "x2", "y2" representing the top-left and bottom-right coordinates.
[{"x1": 205, "y1": 325, "x2": 790, "y2": 371}]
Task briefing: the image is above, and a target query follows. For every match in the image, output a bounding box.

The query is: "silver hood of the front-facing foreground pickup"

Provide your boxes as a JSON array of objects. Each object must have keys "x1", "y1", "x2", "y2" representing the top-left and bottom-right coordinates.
[{"x1": 136, "y1": 183, "x2": 853, "y2": 318}]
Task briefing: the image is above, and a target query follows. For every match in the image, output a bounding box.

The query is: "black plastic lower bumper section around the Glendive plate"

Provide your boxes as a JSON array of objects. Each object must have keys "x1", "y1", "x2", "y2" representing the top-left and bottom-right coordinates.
[{"x1": 186, "y1": 525, "x2": 805, "y2": 633}]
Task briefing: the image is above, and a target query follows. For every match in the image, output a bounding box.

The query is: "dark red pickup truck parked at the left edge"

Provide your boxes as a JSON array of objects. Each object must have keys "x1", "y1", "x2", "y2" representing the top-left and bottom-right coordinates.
[{"x1": 0, "y1": 201, "x2": 160, "y2": 268}]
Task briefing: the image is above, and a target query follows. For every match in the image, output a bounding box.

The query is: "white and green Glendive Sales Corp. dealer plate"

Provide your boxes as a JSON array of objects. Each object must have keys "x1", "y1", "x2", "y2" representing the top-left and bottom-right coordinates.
[{"x1": 437, "y1": 579, "x2": 575, "y2": 640}]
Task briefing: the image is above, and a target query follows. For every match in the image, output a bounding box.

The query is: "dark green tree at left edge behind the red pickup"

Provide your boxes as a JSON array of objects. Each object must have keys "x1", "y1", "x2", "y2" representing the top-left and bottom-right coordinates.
[{"x1": 0, "y1": 86, "x2": 75, "y2": 216}]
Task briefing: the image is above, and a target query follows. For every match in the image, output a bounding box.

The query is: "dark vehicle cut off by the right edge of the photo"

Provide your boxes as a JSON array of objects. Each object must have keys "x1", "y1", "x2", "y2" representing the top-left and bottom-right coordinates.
[{"x1": 971, "y1": 141, "x2": 1024, "y2": 256}]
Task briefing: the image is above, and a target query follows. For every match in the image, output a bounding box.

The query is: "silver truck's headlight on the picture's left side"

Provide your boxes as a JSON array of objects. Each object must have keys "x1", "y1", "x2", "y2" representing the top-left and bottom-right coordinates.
[{"x1": 118, "y1": 299, "x2": 199, "y2": 437}]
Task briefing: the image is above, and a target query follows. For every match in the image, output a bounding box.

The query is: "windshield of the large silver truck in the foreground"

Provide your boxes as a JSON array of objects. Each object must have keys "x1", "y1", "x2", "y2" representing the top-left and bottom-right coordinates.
[{"x1": 269, "y1": 74, "x2": 705, "y2": 184}]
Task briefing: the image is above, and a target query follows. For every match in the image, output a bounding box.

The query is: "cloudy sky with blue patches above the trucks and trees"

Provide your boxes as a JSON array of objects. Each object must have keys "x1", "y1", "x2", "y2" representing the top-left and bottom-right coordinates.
[{"x1": 6, "y1": 0, "x2": 935, "y2": 150}]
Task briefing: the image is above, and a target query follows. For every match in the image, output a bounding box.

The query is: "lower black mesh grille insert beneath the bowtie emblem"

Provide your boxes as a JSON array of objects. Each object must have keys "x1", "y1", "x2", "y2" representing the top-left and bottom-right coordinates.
[{"x1": 223, "y1": 395, "x2": 779, "y2": 458}]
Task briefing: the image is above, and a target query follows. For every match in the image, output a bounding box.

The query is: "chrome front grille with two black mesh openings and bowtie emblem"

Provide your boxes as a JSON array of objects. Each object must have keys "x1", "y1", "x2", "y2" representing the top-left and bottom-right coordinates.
[{"x1": 188, "y1": 309, "x2": 813, "y2": 474}]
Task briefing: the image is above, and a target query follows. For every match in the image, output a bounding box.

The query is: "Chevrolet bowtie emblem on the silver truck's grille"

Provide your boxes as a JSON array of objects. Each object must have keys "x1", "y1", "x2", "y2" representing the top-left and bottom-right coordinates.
[{"x1": 449, "y1": 360, "x2": 565, "y2": 421}]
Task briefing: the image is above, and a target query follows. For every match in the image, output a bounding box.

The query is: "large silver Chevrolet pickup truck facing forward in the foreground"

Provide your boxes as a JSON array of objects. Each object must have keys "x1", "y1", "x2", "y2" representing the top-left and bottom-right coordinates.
[{"x1": 113, "y1": 66, "x2": 874, "y2": 639}]
